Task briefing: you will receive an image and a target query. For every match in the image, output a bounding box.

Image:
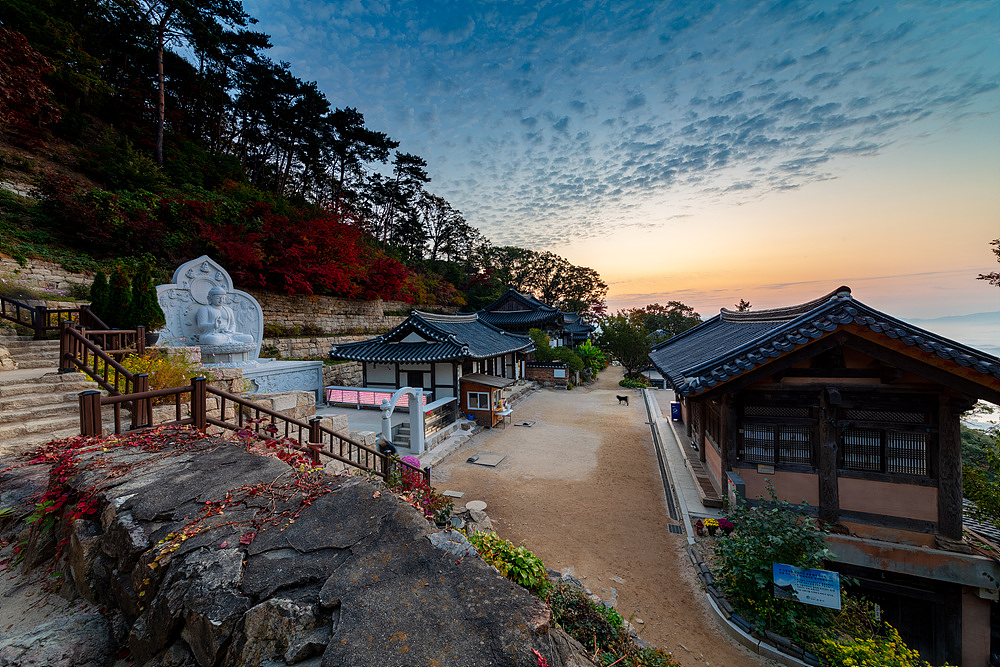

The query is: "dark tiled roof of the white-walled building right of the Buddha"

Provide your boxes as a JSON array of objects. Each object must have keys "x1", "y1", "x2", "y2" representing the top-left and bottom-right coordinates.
[{"x1": 330, "y1": 311, "x2": 532, "y2": 363}]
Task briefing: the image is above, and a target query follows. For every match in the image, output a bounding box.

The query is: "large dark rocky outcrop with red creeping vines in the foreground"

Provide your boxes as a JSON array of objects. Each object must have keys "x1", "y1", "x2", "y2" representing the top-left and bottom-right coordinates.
[{"x1": 0, "y1": 429, "x2": 592, "y2": 667}]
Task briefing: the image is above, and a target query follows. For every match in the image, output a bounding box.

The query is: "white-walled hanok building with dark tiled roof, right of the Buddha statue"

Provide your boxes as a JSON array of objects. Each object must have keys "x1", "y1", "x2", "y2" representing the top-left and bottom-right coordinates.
[{"x1": 330, "y1": 311, "x2": 534, "y2": 401}]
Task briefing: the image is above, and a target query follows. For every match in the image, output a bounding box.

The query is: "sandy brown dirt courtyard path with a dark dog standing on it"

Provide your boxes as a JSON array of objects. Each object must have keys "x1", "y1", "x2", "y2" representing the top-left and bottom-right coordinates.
[{"x1": 434, "y1": 368, "x2": 774, "y2": 667}]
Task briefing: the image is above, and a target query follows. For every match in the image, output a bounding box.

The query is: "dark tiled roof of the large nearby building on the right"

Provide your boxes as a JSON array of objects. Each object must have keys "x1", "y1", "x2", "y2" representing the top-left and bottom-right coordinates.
[{"x1": 649, "y1": 287, "x2": 1000, "y2": 396}]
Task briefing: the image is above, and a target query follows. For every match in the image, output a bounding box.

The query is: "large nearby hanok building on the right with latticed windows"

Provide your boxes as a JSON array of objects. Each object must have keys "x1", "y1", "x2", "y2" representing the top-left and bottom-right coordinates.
[{"x1": 650, "y1": 287, "x2": 1000, "y2": 667}]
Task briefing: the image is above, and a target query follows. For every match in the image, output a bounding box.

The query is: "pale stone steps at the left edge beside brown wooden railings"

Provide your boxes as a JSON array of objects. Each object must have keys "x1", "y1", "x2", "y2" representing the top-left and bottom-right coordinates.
[{"x1": 0, "y1": 330, "x2": 105, "y2": 456}]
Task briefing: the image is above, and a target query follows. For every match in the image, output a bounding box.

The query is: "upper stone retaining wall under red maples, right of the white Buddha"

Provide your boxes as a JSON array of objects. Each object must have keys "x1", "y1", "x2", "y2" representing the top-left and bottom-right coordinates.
[{"x1": 246, "y1": 290, "x2": 413, "y2": 334}]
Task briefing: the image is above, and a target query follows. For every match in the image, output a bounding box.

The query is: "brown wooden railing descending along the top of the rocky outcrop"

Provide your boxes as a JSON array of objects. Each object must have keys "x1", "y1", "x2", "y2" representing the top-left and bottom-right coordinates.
[{"x1": 80, "y1": 374, "x2": 431, "y2": 484}]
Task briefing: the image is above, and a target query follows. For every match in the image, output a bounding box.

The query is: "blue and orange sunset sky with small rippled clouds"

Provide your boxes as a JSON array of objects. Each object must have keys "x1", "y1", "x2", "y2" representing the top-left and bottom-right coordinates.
[{"x1": 244, "y1": 0, "x2": 1000, "y2": 332}]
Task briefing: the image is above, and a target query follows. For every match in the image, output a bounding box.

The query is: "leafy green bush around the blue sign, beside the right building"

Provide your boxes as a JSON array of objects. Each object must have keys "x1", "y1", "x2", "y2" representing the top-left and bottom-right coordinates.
[{"x1": 715, "y1": 484, "x2": 830, "y2": 640}]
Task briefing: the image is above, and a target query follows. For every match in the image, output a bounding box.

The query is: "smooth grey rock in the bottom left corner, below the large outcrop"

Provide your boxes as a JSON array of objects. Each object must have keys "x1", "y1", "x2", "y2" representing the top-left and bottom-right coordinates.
[{"x1": 0, "y1": 611, "x2": 115, "y2": 667}]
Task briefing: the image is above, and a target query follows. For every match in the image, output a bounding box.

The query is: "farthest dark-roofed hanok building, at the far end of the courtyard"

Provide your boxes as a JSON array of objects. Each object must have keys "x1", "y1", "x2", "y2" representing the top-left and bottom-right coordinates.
[{"x1": 478, "y1": 287, "x2": 594, "y2": 347}]
